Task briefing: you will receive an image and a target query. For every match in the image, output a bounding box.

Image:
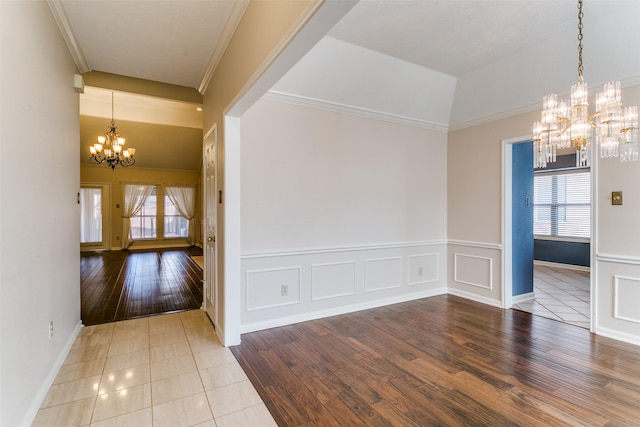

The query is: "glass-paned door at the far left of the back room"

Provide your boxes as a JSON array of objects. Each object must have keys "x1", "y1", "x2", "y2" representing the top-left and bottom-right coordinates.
[{"x1": 78, "y1": 184, "x2": 110, "y2": 251}]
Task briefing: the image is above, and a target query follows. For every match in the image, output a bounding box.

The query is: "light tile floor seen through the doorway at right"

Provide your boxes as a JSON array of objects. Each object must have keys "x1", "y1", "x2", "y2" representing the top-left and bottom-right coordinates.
[{"x1": 513, "y1": 265, "x2": 591, "y2": 329}]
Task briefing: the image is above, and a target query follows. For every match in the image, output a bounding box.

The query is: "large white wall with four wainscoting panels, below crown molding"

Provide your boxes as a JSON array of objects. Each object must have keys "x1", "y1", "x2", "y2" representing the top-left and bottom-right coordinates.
[{"x1": 241, "y1": 100, "x2": 447, "y2": 331}]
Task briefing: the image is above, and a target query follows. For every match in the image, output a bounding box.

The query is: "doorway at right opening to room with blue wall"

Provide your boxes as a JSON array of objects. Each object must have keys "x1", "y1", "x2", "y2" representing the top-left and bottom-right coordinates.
[{"x1": 503, "y1": 137, "x2": 592, "y2": 329}]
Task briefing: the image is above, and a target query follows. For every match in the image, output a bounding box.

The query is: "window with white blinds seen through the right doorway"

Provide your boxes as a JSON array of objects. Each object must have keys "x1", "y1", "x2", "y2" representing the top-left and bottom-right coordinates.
[{"x1": 533, "y1": 171, "x2": 591, "y2": 238}]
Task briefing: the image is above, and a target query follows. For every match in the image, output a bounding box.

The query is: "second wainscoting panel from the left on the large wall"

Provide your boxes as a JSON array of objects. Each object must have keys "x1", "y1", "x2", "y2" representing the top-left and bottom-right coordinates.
[{"x1": 311, "y1": 261, "x2": 356, "y2": 301}]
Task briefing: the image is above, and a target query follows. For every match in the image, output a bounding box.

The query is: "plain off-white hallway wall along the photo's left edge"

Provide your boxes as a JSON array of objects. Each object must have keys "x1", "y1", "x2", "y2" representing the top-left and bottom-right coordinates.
[{"x1": 0, "y1": 1, "x2": 80, "y2": 426}]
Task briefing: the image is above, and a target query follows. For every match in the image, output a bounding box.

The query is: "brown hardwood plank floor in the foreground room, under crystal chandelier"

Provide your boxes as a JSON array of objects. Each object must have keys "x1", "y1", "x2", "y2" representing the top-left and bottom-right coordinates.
[{"x1": 231, "y1": 296, "x2": 640, "y2": 426}]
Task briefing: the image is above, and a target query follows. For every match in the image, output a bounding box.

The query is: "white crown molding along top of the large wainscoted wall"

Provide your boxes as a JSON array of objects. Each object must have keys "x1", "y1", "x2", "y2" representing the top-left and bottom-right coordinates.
[{"x1": 262, "y1": 90, "x2": 449, "y2": 133}]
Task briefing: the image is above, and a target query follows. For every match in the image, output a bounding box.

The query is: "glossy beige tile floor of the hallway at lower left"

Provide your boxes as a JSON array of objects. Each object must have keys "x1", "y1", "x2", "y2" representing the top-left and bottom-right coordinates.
[{"x1": 33, "y1": 310, "x2": 276, "y2": 427}]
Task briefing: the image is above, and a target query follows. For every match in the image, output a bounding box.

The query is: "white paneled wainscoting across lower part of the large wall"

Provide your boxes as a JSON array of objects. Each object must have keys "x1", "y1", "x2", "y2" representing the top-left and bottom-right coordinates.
[{"x1": 241, "y1": 241, "x2": 447, "y2": 333}]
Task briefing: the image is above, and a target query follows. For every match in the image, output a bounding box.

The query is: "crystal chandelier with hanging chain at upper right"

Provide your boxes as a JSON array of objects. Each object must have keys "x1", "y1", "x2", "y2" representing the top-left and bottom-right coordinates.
[{"x1": 533, "y1": 0, "x2": 638, "y2": 168}]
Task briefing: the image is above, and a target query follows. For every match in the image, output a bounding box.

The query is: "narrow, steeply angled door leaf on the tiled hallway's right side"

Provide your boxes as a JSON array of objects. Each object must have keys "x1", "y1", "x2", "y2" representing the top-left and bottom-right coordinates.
[{"x1": 203, "y1": 126, "x2": 219, "y2": 328}]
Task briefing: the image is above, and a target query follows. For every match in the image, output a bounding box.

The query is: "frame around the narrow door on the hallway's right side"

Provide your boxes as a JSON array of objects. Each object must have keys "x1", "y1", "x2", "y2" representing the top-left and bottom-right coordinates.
[{"x1": 202, "y1": 124, "x2": 223, "y2": 332}]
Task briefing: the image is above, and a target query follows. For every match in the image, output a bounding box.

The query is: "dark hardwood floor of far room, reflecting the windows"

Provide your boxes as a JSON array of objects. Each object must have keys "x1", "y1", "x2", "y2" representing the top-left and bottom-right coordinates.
[{"x1": 80, "y1": 246, "x2": 202, "y2": 325}]
